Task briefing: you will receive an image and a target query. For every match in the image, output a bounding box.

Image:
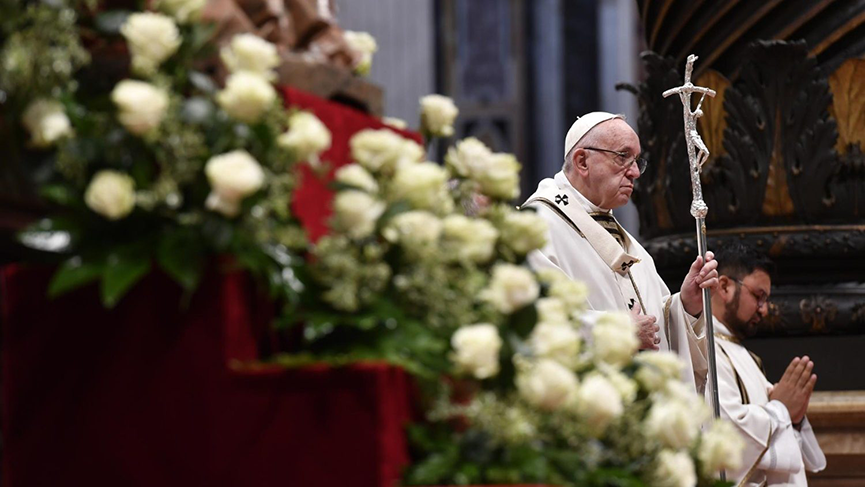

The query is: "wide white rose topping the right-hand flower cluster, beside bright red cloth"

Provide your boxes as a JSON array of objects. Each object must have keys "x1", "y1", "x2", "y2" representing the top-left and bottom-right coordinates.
[{"x1": 349, "y1": 129, "x2": 425, "y2": 173}]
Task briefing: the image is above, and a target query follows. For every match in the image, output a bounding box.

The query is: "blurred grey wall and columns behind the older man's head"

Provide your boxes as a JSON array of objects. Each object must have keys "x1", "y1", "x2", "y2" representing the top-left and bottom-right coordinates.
[{"x1": 335, "y1": 0, "x2": 642, "y2": 233}]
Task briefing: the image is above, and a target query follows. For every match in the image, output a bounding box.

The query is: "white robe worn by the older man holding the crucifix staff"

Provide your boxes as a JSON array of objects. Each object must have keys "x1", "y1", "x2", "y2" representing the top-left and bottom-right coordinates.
[{"x1": 523, "y1": 171, "x2": 708, "y2": 393}]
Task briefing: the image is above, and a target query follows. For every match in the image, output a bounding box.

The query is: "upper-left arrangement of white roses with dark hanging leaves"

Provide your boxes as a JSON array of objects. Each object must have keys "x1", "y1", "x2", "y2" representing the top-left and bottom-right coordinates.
[{"x1": 0, "y1": 0, "x2": 330, "y2": 306}]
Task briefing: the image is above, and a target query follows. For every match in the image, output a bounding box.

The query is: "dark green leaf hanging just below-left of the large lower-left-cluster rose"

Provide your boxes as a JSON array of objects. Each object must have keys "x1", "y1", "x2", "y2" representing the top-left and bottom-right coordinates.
[{"x1": 156, "y1": 228, "x2": 205, "y2": 292}]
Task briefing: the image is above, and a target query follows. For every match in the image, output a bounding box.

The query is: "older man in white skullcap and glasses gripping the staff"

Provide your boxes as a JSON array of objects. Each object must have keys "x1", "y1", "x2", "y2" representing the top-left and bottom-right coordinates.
[{"x1": 522, "y1": 112, "x2": 717, "y2": 392}]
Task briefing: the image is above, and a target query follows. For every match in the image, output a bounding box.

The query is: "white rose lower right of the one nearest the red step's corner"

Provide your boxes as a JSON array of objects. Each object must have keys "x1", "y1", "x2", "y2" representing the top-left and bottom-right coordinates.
[{"x1": 516, "y1": 358, "x2": 579, "y2": 411}]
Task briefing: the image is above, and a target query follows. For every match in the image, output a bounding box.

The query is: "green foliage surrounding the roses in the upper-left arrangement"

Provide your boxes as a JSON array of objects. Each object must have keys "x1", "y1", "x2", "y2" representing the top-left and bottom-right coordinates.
[{"x1": 6, "y1": 0, "x2": 309, "y2": 313}]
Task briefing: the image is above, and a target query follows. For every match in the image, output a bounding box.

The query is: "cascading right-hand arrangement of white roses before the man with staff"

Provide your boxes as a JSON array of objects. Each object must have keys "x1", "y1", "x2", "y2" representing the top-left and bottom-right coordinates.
[{"x1": 310, "y1": 132, "x2": 744, "y2": 486}]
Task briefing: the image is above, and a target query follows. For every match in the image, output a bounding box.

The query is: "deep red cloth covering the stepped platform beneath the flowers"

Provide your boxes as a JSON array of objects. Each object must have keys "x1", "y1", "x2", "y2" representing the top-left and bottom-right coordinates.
[{"x1": 0, "y1": 89, "x2": 419, "y2": 487}]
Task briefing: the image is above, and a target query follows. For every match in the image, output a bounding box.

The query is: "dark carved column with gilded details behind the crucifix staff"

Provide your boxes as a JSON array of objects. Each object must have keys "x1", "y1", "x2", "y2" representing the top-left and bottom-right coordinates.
[{"x1": 622, "y1": 0, "x2": 865, "y2": 335}]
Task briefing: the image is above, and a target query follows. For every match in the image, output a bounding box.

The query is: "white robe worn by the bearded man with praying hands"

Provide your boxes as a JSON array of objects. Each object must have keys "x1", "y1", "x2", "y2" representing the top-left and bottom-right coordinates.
[{"x1": 714, "y1": 318, "x2": 826, "y2": 486}]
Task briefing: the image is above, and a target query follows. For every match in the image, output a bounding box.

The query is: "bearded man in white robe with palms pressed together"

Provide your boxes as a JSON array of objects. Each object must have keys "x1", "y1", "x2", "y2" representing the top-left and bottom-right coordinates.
[{"x1": 712, "y1": 244, "x2": 826, "y2": 486}]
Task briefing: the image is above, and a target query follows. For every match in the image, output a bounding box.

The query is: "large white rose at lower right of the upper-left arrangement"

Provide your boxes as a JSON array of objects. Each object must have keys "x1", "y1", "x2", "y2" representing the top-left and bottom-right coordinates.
[{"x1": 204, "y1": 150, "x2": 264, "y2": 217}]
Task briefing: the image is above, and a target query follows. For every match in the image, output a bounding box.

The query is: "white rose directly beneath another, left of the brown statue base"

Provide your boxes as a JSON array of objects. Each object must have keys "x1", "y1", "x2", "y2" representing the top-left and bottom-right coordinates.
[{"x1": 216, "y1": 71, "x2": 276, "y2": 123}]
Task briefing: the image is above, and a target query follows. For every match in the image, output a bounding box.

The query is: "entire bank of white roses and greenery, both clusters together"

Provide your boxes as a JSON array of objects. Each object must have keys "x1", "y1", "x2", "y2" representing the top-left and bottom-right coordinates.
[{"x1": 0, "y1": 0, "x2": 741, "y2": 486}]
